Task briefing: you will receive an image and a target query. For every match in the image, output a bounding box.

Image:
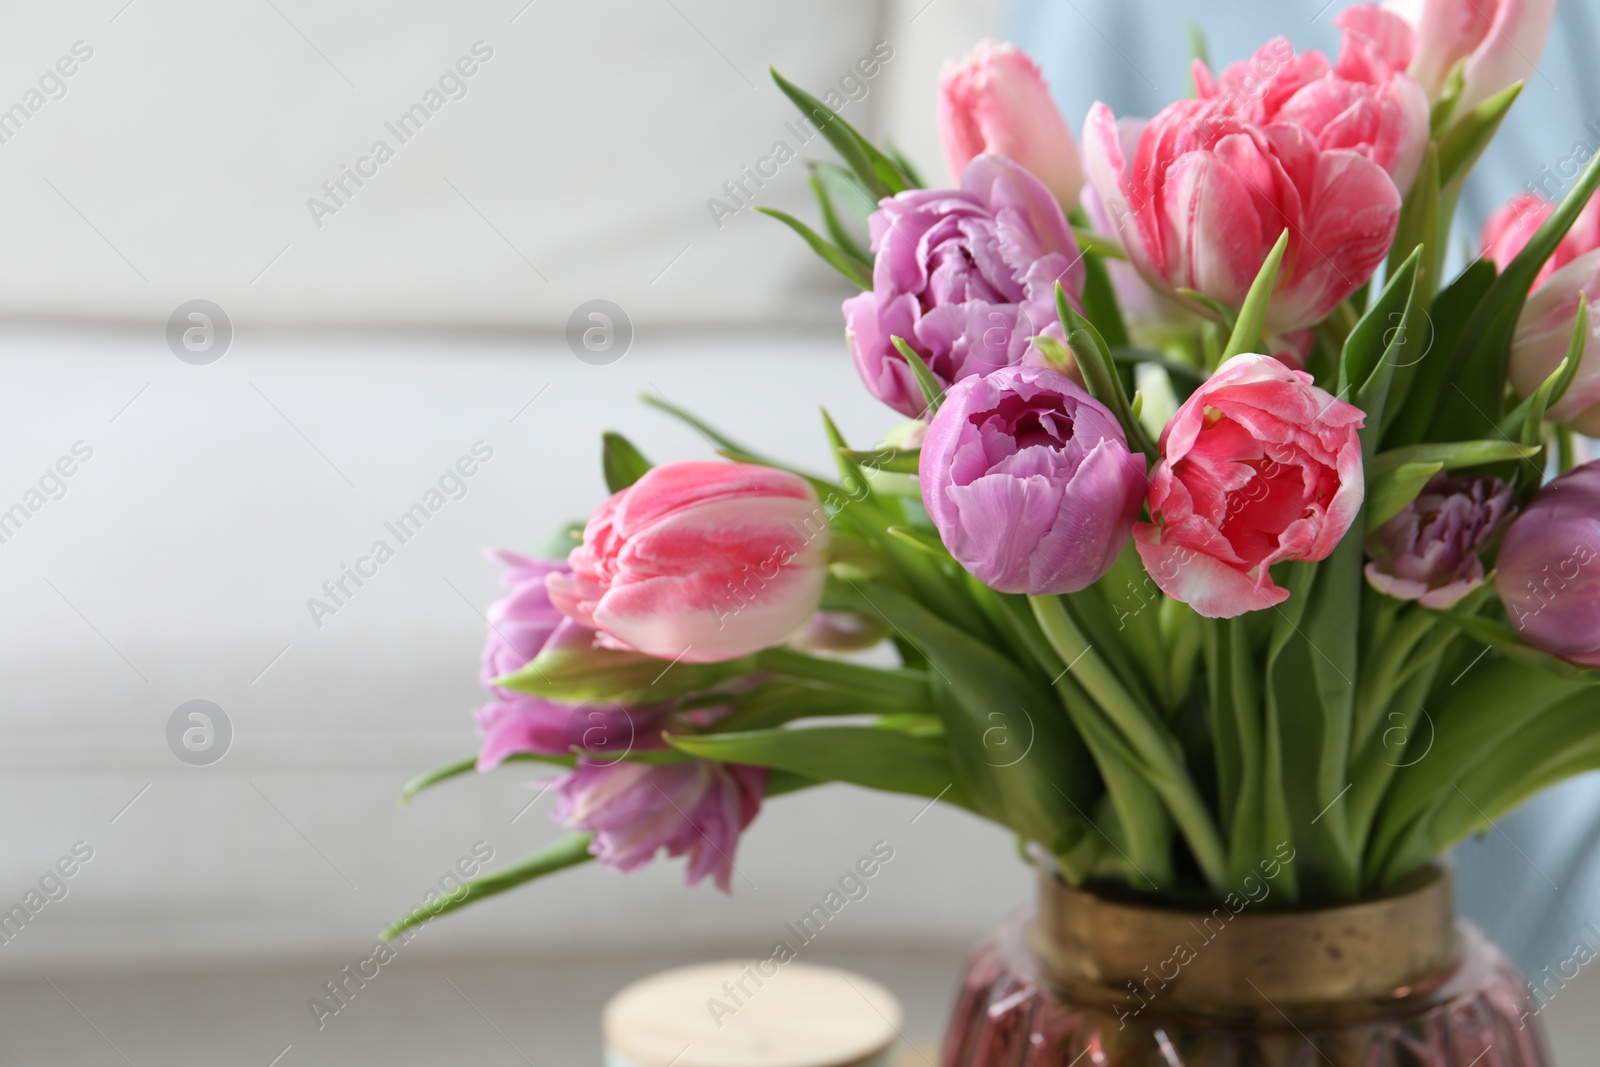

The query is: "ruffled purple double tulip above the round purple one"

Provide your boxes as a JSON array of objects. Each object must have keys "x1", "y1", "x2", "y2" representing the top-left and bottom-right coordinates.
[{"x1": 843, "y1": 155, "x2": 1083, "y2": 418}]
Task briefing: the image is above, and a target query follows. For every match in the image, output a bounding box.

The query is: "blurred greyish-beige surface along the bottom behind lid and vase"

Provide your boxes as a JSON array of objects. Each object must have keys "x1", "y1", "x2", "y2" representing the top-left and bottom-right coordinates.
[{"x1": 0, "y1": 942, "x2": 1600, "y2": 1067}]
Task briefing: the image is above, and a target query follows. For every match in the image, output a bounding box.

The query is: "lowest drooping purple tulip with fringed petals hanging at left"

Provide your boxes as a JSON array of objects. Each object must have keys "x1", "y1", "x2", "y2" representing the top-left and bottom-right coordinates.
[{"x1": 554, "y1": 761, "x2": 766, "y2": 893}]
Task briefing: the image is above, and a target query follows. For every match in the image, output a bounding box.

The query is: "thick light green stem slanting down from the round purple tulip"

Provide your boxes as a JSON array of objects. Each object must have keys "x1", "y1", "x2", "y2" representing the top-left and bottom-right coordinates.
[{"x1": 1029, "y1": 597, "x2": 1229, "y2": 894}]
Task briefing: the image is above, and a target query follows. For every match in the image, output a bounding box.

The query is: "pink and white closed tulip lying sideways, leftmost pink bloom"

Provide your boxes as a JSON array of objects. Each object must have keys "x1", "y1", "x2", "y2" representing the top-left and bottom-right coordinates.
[{"x1": 546, "y1": 462, "x2": 830, "y2": 664}]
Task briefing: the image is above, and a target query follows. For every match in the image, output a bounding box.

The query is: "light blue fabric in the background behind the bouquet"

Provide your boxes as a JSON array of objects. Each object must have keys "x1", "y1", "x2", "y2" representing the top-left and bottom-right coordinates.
[{"x1": 1006, "y1": 0, "x2": 1600, "y2": 976}]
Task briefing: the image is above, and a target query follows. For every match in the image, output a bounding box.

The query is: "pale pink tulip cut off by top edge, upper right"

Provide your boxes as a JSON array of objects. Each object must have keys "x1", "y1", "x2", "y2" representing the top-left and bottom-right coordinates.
[{"x1": 1384, "y1": 0, "x2": 1557, "y2": 115}]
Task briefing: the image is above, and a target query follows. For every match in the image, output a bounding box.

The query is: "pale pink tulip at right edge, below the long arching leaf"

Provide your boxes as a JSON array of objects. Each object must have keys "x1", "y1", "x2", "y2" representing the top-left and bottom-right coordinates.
[{"x1": 1510, "y1": 250, "x2": 1600, "y2": 437}]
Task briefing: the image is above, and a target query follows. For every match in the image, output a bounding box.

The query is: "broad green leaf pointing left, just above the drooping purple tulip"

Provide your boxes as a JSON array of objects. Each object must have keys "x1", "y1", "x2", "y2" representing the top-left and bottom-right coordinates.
[{"x1": 667, "y1": 726, "x2": 970, "y2": 808}]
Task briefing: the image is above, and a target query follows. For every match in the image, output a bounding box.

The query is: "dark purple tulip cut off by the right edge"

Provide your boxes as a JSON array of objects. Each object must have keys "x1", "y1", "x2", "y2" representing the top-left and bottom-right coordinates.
[{"x1": 1494, "y1": 461, "x2": 1600, "y2": 667}]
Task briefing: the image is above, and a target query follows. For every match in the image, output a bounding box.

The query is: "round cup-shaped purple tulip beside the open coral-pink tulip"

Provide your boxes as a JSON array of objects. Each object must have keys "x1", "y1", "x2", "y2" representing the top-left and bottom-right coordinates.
[{"x1": 922, "y1": 366, "x2": 1146, "y2": 595}]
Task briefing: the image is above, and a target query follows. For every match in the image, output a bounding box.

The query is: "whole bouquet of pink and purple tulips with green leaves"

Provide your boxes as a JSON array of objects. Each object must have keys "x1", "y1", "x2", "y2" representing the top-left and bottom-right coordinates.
[{"x1": 387, "y1": 0, "x2": 1600, "y2": 929}]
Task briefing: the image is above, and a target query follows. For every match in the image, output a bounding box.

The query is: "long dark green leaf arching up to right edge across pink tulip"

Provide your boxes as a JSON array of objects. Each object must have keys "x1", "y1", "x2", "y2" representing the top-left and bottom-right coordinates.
[{"x1": 1429, "y1": 140, "x2": 1600, "y2": 440}]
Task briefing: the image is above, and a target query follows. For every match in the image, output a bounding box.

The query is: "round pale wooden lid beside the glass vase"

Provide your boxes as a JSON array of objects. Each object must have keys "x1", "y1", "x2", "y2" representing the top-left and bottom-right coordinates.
[{"x1": 603, "y1": 960, "x2": 901, "y2": 1067}]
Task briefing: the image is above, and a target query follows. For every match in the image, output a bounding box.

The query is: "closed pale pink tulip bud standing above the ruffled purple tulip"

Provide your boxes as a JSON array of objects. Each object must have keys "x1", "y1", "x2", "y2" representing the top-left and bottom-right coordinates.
[{"x1": 939, "y1": 42, "x2": 1083, "y2": 210}]
